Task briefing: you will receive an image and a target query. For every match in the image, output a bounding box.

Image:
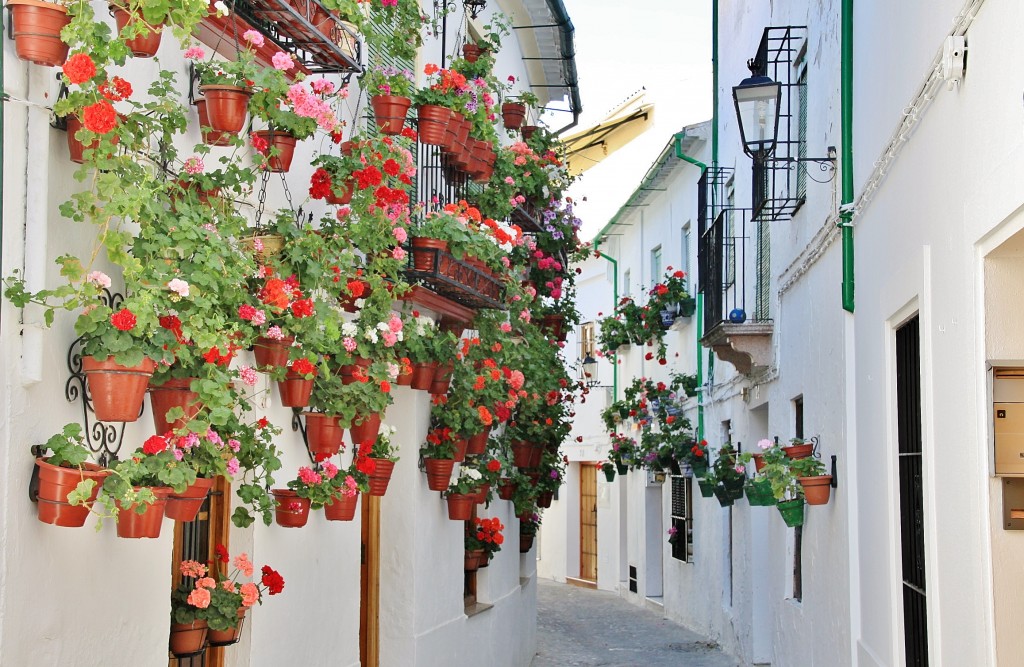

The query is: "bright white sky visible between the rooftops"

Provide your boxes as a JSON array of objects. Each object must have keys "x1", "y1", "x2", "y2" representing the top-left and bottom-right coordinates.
[{"x1": 546, "y1": 0, "x2": 712, "y2": 239}]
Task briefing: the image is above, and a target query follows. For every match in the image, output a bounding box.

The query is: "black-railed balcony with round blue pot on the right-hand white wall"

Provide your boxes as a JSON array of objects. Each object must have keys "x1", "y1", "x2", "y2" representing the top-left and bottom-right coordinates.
[{"x1": 697, "y1": 168, "x2": 772, "y2": 375}]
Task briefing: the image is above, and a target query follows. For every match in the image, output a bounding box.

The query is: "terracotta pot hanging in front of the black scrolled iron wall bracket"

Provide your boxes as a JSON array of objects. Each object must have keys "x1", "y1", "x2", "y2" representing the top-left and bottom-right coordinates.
[{"x1": 82, "y1": 357, "x2": 157, "y2": 421}]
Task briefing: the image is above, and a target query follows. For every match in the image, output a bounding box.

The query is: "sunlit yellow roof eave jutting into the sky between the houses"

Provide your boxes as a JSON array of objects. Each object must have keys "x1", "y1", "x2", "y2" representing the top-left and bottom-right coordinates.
[{"x1": 562, "y1": 92, "x2": 654, "y2": 174}]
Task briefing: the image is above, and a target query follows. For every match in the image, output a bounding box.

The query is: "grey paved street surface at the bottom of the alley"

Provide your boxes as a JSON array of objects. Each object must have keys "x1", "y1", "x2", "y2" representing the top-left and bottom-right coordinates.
[{"x1": 532, "y1": 580, "x2": 738, "y2": 667}]
